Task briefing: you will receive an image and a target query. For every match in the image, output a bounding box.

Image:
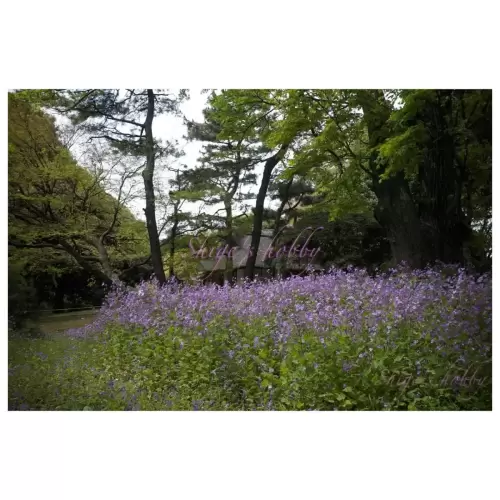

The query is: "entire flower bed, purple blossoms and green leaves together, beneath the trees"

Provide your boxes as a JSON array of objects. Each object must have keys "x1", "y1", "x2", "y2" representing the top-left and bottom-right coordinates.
[{"x1": 9, "y1": 268, "x2": 492, "y2": 410}]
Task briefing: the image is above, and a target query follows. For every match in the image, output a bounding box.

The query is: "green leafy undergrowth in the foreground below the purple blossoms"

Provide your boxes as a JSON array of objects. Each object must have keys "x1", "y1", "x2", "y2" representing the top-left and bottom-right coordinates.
[{"x1": 9, "y1": 319, "x2": 492, "y2": 410}]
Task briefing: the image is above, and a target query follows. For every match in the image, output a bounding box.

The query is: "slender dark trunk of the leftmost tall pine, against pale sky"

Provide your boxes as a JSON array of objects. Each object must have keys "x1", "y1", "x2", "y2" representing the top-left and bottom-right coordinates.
[{"x1": 142, "y1": 89, "x2": 166, "y2": 285}]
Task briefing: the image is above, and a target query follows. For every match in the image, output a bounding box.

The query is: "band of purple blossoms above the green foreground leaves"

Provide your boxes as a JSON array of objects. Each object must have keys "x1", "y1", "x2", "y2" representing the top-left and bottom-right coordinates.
[{"x1": 68, "y1": 268, "x2": 492, "y2": 350}]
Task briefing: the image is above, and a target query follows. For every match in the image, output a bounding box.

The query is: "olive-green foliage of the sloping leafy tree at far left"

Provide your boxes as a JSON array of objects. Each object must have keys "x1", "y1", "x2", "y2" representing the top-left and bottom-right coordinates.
[{"x1": 8, "y1": 93, "x2": 148, "y2": 282}]
